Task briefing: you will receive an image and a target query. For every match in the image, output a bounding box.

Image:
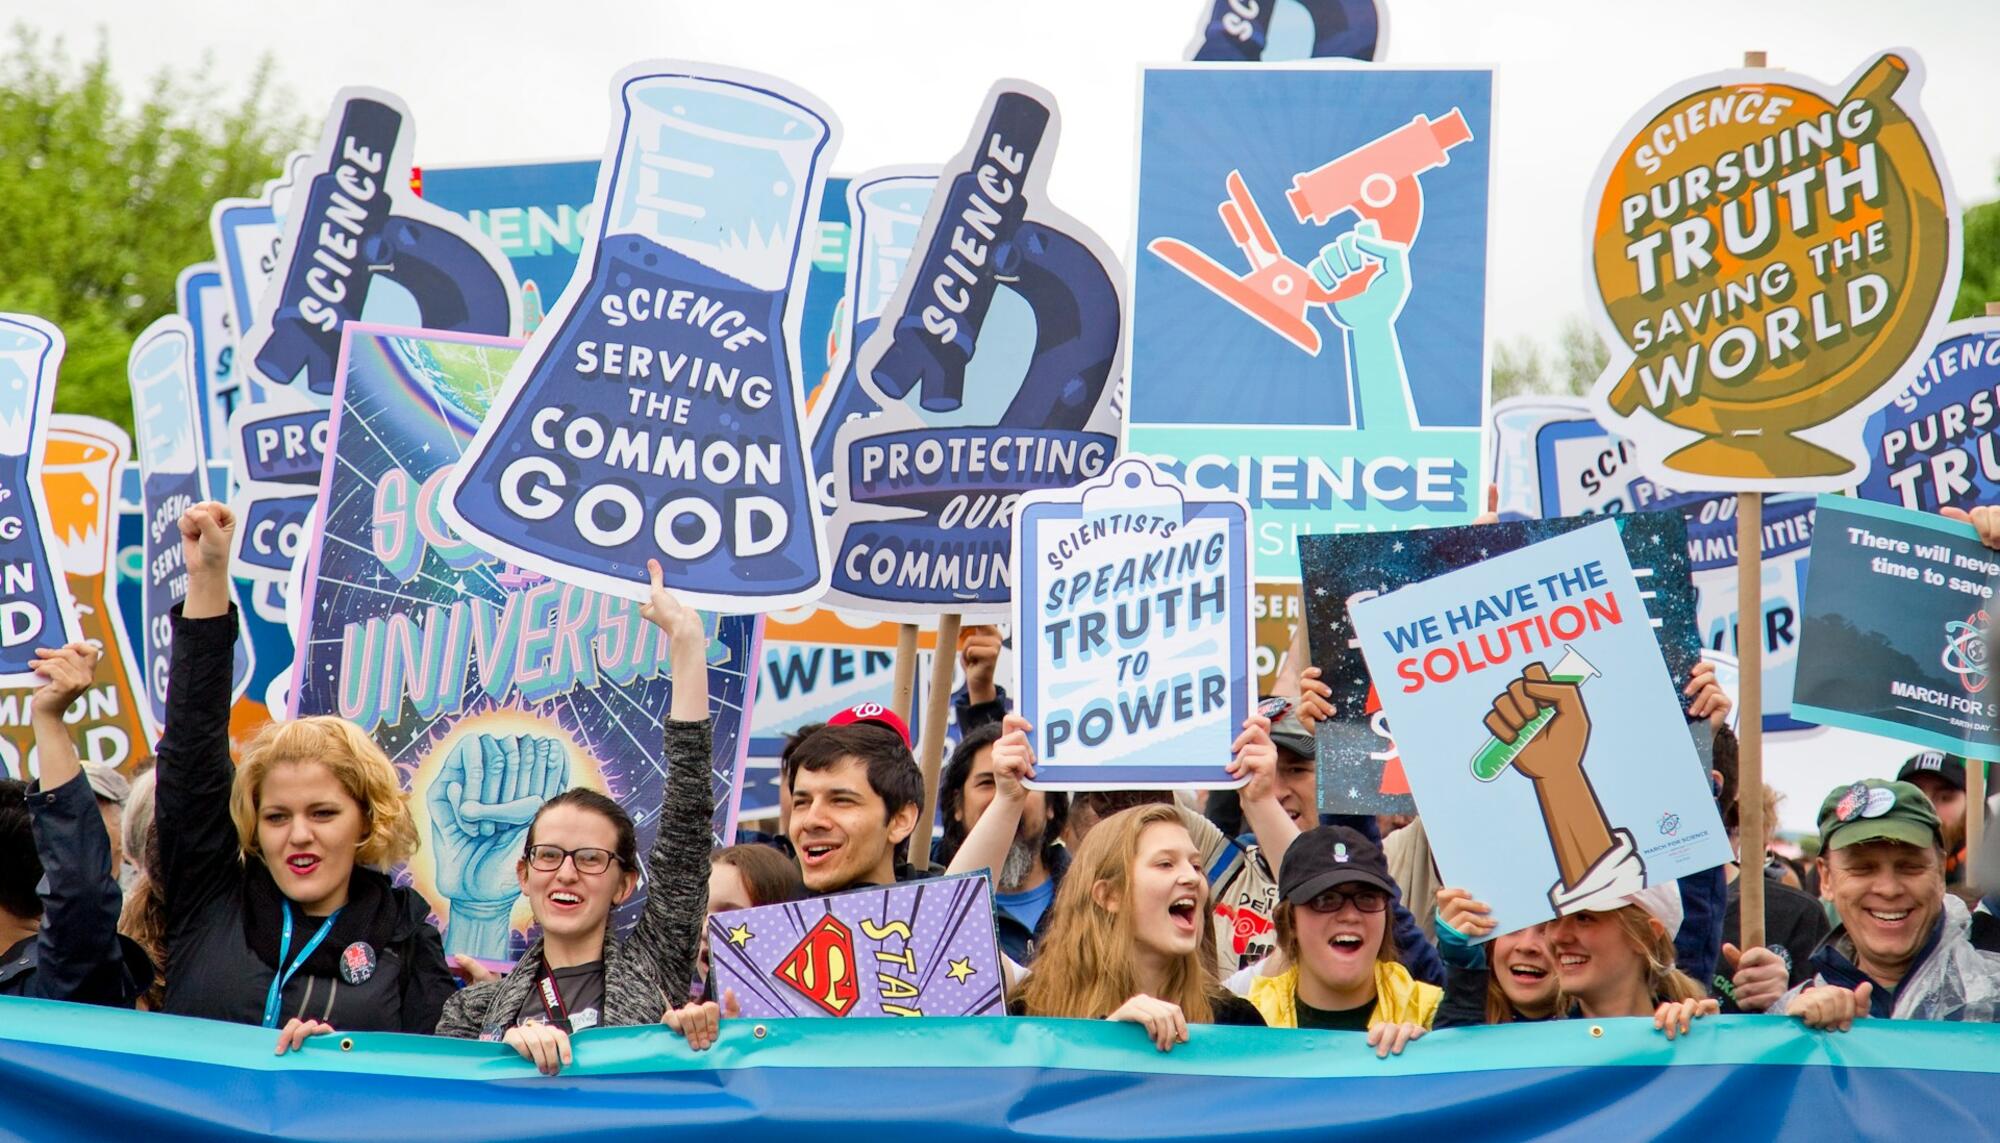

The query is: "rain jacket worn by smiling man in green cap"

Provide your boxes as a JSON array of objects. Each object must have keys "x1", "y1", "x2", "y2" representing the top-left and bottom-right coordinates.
[{"x1": 1770, "y1": 893, "x2": 2000, "y2": 1023}]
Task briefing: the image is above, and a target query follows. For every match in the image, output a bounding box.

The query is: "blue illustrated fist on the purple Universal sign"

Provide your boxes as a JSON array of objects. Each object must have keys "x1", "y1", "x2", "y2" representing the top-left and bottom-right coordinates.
[{"x1": 426, "y1": 733, "x2": 570, "y2": 961}]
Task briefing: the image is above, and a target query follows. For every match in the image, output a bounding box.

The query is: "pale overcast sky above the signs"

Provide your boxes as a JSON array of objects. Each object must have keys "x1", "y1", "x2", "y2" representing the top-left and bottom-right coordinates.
[{"x1": 27, "y1": 0, "x2": 2000, "y2": 353}]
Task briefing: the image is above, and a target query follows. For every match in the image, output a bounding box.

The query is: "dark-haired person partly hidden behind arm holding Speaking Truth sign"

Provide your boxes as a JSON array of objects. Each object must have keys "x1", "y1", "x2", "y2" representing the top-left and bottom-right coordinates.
[{"x1": 932, "y1": 723, "x2": 1070, "y2": 965}]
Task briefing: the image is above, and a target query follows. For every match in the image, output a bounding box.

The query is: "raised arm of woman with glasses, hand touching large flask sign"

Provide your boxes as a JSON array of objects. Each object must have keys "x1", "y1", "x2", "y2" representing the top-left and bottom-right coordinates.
[{"x1": 632, "y1": 560, "x2": 714, "y2": 1007}]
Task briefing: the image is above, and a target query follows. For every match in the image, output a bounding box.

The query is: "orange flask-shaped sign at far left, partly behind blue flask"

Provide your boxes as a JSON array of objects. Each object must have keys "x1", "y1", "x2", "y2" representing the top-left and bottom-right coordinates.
[{"x1": 0, "y1": 414, "x2": 156, "y2": 777}]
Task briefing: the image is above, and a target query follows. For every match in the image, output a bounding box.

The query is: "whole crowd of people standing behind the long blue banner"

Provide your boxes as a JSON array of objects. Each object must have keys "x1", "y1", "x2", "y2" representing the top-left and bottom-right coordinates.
[{"x1": 0, "y1": 504, "x2": 2000, "y2": 1075}]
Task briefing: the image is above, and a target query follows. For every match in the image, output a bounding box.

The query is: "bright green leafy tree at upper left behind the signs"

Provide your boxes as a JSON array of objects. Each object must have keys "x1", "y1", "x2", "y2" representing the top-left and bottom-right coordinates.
[{"x1": 0, "y1": 26, "x2": 306, "y2": 430}]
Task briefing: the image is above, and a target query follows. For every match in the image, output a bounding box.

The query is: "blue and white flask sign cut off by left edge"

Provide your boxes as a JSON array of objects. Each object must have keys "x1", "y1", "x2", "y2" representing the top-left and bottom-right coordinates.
[{"x1": 0, "y1": 314, "x2": 82, "y2": 687}]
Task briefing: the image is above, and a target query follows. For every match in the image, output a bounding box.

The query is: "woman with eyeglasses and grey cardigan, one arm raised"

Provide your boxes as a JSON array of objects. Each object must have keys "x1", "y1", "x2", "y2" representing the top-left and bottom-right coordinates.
[{"x1": 438, "y1": 562, "x2": 712, "y2": 1075}]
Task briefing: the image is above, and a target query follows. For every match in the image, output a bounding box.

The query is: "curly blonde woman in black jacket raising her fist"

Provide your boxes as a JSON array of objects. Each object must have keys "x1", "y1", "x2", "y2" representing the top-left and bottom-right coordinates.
[{"x1": 150, "y1": 502, "x2": 452, "y2": 1053}]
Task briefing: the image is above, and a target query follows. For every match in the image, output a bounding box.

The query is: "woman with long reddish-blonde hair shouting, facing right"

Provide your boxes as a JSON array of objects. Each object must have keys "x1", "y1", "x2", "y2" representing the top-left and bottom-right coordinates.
[{"x1": 1016, "y1": 805, "x2": 1264, "y2": 1051}]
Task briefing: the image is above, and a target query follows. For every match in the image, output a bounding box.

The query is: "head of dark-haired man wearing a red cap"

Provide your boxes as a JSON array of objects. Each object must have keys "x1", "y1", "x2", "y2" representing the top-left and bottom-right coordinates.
[{"x1": 780, "y1": 703, "x2": 924, "y2": 895}]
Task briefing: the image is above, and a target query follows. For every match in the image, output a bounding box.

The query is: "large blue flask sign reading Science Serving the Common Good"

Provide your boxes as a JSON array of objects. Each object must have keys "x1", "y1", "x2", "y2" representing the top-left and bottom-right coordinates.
[{"x1": 442, "y1": 62, "x2": 840, "y2": 611}]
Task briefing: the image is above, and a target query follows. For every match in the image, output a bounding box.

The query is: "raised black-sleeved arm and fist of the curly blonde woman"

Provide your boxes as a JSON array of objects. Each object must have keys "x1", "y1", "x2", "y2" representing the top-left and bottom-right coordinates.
[{"x1": 154, "y1": 500, "x2": 240, "y2": 927}]
